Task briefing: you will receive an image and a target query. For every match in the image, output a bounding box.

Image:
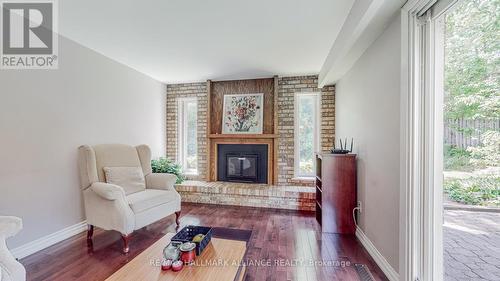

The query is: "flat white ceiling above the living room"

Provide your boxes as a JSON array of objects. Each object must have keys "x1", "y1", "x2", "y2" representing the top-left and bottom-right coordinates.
[{"x1": 59, "y1": 0, "x2": 354, "y2": 83}]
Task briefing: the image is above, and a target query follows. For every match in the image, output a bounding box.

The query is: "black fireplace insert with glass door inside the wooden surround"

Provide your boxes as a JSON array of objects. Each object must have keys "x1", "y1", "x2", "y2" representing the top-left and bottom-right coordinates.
[{"x1": 217, "y1": 144, "x2": 268, "y2": 183}]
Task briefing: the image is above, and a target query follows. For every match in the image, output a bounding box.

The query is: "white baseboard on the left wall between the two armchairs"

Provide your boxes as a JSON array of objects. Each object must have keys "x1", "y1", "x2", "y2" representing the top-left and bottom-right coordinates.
[{"x1": 11, "y1": 221, "x2": 87, "y2": 259}]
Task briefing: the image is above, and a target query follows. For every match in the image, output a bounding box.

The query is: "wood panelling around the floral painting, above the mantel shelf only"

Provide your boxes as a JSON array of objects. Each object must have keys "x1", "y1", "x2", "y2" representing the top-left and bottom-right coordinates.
[{"x1": 209, "y1": 78, "x2": 275, "y2": 135}]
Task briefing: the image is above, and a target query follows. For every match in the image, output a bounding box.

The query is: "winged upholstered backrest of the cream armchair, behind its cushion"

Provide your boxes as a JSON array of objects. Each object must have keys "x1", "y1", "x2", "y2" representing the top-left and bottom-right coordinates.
[{"x1": 78, "y1": 144, "x2": 152, "y2": 189}]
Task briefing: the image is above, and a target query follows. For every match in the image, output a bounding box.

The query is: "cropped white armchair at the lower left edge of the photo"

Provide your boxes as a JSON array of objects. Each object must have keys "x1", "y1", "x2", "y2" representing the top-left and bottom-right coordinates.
[{"x1": 0, "y1": 216, "x2": 26, "y2": 281}]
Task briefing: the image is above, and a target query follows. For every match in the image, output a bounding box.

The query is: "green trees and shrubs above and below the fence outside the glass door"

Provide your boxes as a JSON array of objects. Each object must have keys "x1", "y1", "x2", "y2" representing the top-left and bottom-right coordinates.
[{"x1": 444, "y1": 0, "x2": 500, "y2": 207}]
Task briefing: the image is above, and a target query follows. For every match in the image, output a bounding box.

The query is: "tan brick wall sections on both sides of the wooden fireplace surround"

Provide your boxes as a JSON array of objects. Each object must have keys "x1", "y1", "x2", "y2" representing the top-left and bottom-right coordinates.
[{"x1": 166, "y1": 75, "x2": 335, "y2": 185}]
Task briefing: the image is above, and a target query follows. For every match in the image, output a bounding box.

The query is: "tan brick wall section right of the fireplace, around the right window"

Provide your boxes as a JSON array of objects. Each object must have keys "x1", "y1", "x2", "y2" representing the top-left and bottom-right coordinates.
[{"x1": 278, "y1": 75, "x2": 335, "y2": 184}]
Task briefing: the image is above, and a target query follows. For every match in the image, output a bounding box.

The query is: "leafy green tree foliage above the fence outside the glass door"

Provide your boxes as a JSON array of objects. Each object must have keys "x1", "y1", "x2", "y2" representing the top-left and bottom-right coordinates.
[{"x1": 445, "y1": 0, "x2": 500, "y2": 119}]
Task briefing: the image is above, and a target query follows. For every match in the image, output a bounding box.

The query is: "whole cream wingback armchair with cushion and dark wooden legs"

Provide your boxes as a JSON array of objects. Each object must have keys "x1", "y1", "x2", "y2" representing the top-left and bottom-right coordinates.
[{"x1": 78, "y1": 144, "x2": 181, "y2": 253}]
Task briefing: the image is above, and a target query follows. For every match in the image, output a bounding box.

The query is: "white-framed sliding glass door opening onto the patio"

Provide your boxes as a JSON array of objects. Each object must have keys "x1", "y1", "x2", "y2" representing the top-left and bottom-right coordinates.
[{"x1": 400, "y1": 0, "x2": 500, "y2": 281}]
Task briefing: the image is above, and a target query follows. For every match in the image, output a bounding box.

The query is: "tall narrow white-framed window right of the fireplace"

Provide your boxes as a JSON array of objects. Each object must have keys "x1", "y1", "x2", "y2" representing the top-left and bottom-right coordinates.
[{"x1": 294, "y1": 93, "x2": 321, "y2": 177}]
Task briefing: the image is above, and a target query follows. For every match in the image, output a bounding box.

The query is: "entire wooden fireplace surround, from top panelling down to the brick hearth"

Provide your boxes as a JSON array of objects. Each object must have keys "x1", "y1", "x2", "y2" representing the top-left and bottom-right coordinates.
[{"x1": 207, "y1": 76, "x2": 278, "y2": 184}]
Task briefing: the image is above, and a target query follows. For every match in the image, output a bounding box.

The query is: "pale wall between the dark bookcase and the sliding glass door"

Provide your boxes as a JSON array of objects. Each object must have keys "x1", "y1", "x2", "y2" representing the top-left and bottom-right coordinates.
[{"x1": 335, "y1": 13, "x2": 401, "y2": 272}]
